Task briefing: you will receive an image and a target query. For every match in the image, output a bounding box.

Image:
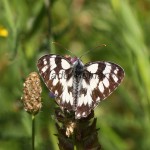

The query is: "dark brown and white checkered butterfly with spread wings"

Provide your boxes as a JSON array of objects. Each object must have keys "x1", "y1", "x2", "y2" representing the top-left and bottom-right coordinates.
[{"x1": 37, "y1": 54, "x2": 124, "y2": 119}]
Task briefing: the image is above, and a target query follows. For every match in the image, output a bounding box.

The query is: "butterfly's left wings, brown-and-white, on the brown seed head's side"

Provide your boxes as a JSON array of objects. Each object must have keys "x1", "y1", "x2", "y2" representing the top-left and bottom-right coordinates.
[{"x1": 37, "y1": 54, "x2": 73, "y2": 111}]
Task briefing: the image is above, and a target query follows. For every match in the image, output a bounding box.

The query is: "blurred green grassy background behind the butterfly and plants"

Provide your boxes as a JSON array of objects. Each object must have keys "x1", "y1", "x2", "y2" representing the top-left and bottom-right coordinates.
[{"x1": 0, "y1": 0, "x2": 150, "y2": 150}]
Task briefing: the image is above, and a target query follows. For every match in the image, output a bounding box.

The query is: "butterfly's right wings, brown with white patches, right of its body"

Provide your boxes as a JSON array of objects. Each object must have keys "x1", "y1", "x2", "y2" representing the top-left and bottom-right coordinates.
[{"x1": 75, "y1": 61, "x2": 124, "y2": 119}]
